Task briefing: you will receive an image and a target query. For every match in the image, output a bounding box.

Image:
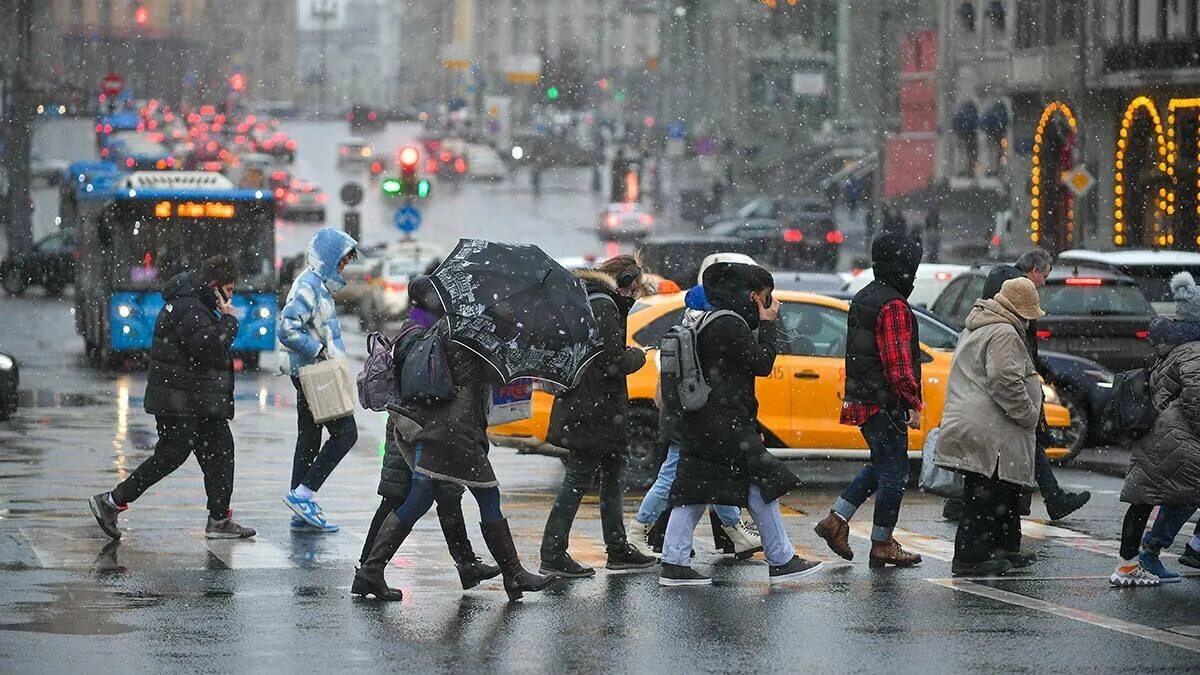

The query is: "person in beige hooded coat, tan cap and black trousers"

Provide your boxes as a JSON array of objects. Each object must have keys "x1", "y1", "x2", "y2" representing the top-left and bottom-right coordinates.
[{"x1": 934, "y1": 277, "x2": 1045, "y2": 577}]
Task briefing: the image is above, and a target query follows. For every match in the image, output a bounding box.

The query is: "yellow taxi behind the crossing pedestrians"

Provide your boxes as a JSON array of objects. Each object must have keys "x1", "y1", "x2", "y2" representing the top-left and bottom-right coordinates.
[{"x1": 490, "y1": 291, "x2": 1070, "y2": 483}]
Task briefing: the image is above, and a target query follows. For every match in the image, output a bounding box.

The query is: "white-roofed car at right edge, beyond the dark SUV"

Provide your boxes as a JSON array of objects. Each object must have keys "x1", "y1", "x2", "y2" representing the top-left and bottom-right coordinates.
[{"x1": 1056, "y1": 249, "x2": 1200, "y2": 315}]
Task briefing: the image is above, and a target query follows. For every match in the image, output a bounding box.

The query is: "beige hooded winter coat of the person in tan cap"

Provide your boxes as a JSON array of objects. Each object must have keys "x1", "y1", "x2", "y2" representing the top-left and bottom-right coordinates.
[{"x1": 934, "y1": 299, "x2": 1042, "y2": 488}]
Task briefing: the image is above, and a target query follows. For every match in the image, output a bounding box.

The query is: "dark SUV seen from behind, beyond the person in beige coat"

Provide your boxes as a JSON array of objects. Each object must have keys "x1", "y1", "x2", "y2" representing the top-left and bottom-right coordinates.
[{"x1": 930, "y1": 265, "x2": 1156, "y2": 372}]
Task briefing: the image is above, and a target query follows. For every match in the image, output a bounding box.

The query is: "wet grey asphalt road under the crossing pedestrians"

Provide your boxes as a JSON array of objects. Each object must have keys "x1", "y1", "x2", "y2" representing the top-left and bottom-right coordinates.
[{"x1": 0, "y1": 118, "x2": 1200, "y2": 673}]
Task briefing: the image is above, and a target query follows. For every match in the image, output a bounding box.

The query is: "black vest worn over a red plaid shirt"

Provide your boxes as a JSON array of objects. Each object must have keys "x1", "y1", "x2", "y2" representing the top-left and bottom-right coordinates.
[{"x1": 846, "y1": 281, "x2": 922, "y2": 410}]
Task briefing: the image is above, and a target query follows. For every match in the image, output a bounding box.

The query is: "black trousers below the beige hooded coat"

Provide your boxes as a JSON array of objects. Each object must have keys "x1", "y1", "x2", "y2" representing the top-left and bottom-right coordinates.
[{"x1": 954, "y1": 473, "x2": 1021, "y2": 563}]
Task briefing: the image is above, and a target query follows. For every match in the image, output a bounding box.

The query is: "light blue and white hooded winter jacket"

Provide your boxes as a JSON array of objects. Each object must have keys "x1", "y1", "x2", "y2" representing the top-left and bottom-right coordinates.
[{"x1": 277, "y1": 227, "x2": 358, "y2": 377}]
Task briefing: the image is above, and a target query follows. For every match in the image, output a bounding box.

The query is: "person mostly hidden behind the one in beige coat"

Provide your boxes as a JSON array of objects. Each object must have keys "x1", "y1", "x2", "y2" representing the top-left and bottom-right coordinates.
[{"x1": 942, "y1": 249, "x2": 1092, "y2": 520}]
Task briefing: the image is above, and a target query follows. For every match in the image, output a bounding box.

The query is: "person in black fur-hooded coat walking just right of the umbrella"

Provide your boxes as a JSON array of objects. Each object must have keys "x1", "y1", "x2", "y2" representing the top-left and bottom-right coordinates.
[{"x1": 540, "y1": 255, "x2": 656, "y2": 578}]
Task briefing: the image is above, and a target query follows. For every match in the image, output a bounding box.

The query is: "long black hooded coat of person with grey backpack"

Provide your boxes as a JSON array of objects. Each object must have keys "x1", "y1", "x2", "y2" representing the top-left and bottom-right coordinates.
[{"x1": 670, "y1": 263, "x2": 800, "y2": 507}]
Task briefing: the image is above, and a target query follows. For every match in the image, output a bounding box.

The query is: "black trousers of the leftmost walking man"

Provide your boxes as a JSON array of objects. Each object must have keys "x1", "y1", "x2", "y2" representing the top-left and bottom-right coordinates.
[{"x1": 113, "y1": 414, "x2": 233, "y2": 520}]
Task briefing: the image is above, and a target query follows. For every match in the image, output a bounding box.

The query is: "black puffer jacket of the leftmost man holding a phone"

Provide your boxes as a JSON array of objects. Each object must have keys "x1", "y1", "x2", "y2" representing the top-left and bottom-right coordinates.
[{"x1": 143, "y1": 266, "x2": 238, "y2": 419}]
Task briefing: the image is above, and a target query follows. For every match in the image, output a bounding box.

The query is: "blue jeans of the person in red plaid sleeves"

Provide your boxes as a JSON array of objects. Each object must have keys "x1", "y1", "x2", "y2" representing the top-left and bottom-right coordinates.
[{"x1": 835, "y1": 411, "x2": 908, "y2": 542}]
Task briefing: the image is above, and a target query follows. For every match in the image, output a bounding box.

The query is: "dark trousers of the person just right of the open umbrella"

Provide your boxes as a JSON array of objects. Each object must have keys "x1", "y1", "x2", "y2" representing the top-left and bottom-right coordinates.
[{"x1": 541, "y1": 450, "x2": 626, "y2": 562}]
